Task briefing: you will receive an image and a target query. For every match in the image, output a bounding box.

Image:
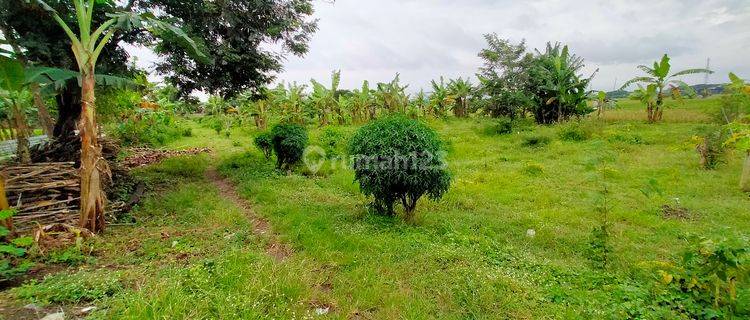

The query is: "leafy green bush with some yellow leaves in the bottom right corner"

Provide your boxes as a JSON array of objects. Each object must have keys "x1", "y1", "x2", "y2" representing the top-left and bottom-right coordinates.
[{"x1": 656, "y1": 238, "x2": 750, "y2": 319}]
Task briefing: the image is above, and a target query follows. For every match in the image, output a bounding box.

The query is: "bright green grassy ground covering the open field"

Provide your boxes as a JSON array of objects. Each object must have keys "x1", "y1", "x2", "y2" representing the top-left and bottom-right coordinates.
[{"x1": 3, "y1": 100, "x2": 750, "y2": 319}]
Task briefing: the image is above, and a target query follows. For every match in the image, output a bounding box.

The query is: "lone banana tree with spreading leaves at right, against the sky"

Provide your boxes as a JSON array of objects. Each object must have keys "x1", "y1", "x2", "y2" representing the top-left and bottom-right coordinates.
[{"x1": 620, "y1": 54, "x2": 713, "y2": 122}]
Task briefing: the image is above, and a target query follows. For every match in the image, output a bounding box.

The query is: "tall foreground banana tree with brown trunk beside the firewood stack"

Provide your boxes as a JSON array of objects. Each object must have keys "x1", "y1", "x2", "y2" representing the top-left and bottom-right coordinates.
[{"x1": 34, "y1": 0, "x2": 207, "y2": 232}]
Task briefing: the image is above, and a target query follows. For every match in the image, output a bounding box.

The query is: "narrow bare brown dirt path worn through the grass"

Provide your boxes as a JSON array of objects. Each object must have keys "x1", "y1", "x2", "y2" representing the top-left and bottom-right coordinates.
[{"x1": 206, "y1": 168, "x2": 293, "y2": 261}]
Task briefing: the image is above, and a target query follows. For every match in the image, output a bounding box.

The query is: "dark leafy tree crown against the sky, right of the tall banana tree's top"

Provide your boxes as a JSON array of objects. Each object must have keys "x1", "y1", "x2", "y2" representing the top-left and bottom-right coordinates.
[{"x1": 142, "y1": 0, "x2": 317, "y2": 98}]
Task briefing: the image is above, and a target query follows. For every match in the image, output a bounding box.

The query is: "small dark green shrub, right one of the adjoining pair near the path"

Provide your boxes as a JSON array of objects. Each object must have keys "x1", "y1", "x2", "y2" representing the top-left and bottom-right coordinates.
[{"x1": 271, "y1": 124, "x2": 307, "y2": 169}]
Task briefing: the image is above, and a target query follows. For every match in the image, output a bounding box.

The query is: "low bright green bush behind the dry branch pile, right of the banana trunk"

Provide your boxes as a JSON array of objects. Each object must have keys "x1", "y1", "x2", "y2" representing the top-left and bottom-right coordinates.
[{"x1": 112, "y1": 109, "x2": 187, "y2": 147}]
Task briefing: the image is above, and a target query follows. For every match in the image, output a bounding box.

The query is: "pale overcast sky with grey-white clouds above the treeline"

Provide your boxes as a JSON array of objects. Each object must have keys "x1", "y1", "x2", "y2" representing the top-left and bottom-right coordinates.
[{"x1": 129, "y1": 0, "x2": 750, "y2": 91}]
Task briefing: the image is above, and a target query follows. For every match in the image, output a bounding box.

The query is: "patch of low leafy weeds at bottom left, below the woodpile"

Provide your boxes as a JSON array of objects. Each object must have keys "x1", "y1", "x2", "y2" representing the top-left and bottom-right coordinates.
[{"x1": 14, "y1": 269, "x2": 124, "y2": 304}]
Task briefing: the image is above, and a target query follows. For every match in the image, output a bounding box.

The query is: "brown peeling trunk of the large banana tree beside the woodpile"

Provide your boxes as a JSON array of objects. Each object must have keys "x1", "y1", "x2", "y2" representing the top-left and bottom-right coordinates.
[{"x1": 78, "y1": 65, "x2": 109, "y2": 232}]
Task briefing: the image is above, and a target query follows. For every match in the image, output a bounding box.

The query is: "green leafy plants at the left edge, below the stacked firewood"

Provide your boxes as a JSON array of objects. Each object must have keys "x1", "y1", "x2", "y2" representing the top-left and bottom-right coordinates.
[{"x1": 0, "y1": 209, "x2": 34, "y2": 283}]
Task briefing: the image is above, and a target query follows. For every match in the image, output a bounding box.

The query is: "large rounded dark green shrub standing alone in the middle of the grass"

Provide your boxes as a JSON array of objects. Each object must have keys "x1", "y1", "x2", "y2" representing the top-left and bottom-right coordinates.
[{"x1": 349, "y1": 116, "x2": 451, "y2": 219}]
